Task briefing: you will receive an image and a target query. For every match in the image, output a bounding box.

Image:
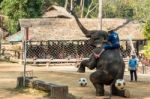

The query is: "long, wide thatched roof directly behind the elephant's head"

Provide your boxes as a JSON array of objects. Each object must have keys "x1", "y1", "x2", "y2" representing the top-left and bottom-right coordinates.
[{"x1": 15, "y1": 18, "x2": 144, "y2": 40}]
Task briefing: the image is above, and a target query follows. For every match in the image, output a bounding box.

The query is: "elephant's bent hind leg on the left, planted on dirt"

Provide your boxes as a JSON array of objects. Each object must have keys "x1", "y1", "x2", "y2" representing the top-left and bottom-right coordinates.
[{"x1": 90, "y1": 70, "x2": 108, "y2": 96}]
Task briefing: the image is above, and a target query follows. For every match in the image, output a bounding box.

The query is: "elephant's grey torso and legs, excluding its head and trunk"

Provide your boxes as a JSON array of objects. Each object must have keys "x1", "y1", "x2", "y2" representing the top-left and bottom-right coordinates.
[{"x1": 78, "y1": 48, "x2": 125, "y2": 96}]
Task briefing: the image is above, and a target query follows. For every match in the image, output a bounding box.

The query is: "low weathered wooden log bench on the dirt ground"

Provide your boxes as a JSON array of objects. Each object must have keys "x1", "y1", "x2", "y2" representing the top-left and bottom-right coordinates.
[{"x1": 16, "y1": 76, "x2": 69, "y2": 99}]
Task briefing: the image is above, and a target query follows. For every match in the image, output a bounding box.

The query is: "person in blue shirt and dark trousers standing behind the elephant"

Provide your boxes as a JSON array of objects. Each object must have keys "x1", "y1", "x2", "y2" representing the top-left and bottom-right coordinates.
[{"x1": 129, "y1": 55, "x2": 138, "y2": 81}]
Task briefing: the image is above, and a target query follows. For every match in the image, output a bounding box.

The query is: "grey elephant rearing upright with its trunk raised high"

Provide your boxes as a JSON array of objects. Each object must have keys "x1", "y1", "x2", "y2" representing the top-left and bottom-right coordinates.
[{"x1": 71, "y1": 11, "x2": 130, "y2": 97}]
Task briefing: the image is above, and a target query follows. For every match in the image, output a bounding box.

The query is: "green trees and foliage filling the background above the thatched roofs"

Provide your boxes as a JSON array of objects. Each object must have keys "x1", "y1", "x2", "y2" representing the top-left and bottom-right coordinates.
[{"x1": 0, "y1": 0, "x2": 150, "y2": 33}]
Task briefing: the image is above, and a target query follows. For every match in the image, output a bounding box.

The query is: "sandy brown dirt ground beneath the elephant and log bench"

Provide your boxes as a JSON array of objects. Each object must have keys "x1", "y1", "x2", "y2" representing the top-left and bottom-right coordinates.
[{"x1": 0, "y1": 62, "x2": 150, "y2": 99}]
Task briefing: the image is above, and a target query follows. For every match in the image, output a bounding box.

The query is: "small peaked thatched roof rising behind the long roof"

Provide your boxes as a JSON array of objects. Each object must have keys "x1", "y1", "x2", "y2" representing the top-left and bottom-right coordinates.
[{"x1": 42, "y1": 5, "x2": 72, "y2": 18}]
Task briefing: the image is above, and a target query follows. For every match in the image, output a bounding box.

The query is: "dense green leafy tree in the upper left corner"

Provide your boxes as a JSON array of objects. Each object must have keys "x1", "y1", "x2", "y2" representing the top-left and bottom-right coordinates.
[{"x1": 1, "y1": 0, "x2": 44, "y2": 33}]
